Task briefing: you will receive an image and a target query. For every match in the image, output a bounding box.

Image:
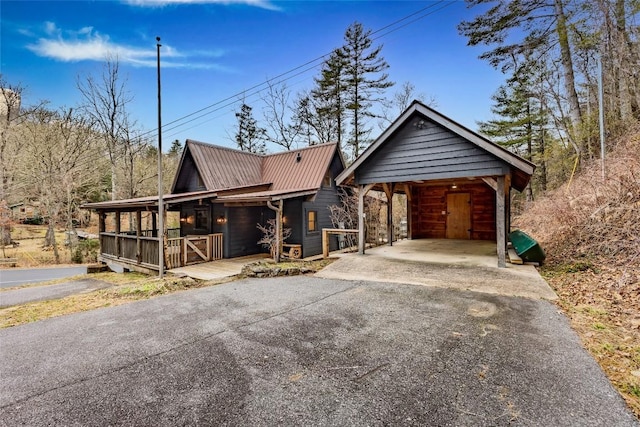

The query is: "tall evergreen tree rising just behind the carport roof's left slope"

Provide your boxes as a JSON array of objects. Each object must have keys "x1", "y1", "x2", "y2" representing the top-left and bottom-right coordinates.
[{"x1": 336, "y1": 22, "x2": 394, "y2": 159}]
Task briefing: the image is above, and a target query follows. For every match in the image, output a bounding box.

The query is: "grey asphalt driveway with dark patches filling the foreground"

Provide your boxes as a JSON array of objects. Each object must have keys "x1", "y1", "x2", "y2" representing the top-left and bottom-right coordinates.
[{"x1": 0, "y1": 276, "x2": 638, "y2": 426}]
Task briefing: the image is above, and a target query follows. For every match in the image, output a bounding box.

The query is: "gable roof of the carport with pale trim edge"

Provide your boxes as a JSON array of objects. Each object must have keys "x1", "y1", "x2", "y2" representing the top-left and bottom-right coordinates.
[{"x1": 336, "y1": 100, "x2": 535, "y2": 191}]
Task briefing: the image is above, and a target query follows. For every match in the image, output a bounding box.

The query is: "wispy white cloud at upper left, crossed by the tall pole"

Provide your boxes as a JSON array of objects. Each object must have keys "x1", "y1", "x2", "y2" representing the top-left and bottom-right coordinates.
[{"x1": 27, "y1": 22, "x2": 230, "y2": 70}]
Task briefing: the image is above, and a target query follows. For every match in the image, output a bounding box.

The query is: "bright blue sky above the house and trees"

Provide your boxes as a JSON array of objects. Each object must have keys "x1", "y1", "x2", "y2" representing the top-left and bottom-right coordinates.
[{"x1": 0, "y1": 0, "x2": 503, "y2": 151}]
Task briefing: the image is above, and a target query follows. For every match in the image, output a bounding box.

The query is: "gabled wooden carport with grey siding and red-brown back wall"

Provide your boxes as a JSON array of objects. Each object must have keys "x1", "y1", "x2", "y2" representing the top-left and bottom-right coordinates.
[{"x1": 336, "y1": 101, "x2": 535, "y2": 267}]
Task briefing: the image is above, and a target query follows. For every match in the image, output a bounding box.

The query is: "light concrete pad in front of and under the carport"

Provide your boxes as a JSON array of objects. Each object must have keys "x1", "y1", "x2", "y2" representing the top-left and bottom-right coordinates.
[{"x1": 316, "y1": 240, "x2": 557, "y2": 300}]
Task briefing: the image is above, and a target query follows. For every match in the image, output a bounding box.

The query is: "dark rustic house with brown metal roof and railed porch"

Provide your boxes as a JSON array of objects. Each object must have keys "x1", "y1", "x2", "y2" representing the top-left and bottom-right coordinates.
[{"x1": 84, "y1": 140, "x2": 345, "y2": 271}]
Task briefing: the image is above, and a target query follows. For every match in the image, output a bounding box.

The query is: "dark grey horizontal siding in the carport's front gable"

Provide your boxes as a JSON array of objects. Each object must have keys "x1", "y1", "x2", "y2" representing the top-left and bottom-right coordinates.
[{"x1": 355, "y1": 120, "x2": 510, "y2": 184}]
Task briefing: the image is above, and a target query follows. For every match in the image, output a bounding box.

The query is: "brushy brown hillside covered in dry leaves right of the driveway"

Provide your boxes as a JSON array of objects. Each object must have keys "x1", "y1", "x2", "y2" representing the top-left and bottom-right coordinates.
[{"x1": 514, "y1": 127, "x2": 640, "y2": 417}]
